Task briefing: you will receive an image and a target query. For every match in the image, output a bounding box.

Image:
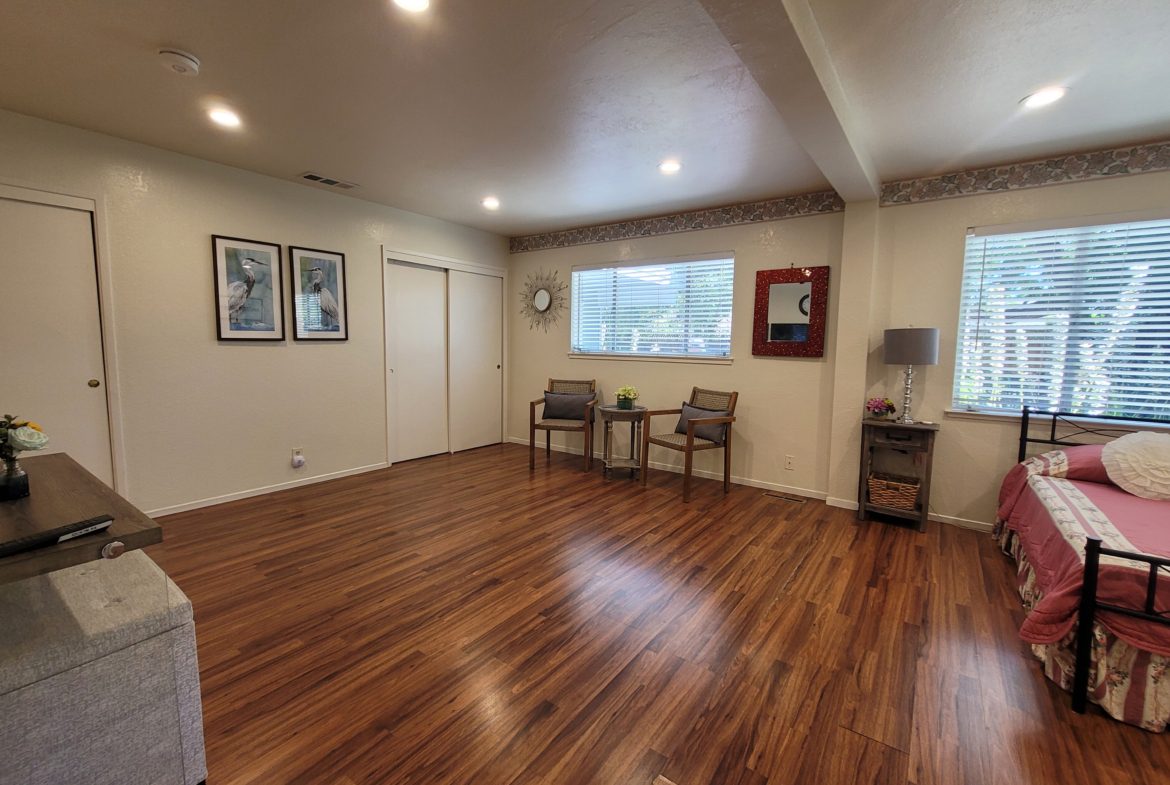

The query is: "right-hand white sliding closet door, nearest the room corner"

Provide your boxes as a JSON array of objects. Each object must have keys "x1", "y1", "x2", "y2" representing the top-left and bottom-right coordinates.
[{"x1": 447, "y1": 270, "x2": 504, "y2": 453}]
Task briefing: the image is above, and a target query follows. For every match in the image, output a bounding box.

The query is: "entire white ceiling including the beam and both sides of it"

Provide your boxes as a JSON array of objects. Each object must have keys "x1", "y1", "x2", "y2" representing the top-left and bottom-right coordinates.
[{"x1": 0, "y1": 0, "x2": 1170, "y2": 235}]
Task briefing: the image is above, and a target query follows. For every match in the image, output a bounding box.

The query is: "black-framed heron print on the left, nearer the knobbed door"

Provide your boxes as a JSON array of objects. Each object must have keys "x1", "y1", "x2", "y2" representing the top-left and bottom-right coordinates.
[{"x1": 212, "y1": 234, "x2": 284, "y2": 340}]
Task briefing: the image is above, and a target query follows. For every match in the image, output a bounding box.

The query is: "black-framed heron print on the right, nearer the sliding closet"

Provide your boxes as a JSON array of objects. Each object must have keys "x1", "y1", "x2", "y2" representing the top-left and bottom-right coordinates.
[{"x1": 289, "y1": 246, "x2": 350, "y2": 340}]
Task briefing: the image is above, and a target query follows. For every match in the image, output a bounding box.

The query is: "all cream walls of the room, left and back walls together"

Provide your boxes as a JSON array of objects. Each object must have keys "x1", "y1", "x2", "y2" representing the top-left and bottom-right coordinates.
[{"x1": 11, "y1": 111, "x2": 1170, "y2": 523}]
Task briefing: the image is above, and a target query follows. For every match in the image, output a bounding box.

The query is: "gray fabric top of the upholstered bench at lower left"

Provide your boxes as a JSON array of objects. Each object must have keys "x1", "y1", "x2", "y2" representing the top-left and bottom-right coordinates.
[{"x1": 0, "y1": 551, "x2": 192, "y2": 695}]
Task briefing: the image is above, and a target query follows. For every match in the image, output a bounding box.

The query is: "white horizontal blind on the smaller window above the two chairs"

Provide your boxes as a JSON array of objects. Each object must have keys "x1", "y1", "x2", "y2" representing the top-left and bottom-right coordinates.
[{"x1": 571, "y1": 259, "x2": 735, "y2": 357}]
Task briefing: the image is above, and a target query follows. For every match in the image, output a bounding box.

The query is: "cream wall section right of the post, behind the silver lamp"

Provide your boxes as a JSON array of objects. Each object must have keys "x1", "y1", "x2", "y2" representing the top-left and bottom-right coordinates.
[{"x1": 869, "y1": 172, "x2": 1170, "y2": 523}]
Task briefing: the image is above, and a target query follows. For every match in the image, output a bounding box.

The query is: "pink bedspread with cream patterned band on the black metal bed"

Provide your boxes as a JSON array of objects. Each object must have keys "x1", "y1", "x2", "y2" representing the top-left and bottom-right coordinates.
[{"x1": 998, "y1": 454, "x2": 1170, "y2": 656}]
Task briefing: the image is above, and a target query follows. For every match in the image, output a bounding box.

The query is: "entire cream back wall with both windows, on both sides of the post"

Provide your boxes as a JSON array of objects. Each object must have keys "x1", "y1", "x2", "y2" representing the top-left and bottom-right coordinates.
[{"x1": 508, "y1": 173, "x2": 1170, "y2": 526}]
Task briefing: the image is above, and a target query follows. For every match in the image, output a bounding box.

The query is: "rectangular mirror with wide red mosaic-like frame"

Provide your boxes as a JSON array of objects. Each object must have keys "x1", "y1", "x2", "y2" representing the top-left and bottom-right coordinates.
[{"x1": 751, "y1": 267, "x2": 828, "y2": 357}]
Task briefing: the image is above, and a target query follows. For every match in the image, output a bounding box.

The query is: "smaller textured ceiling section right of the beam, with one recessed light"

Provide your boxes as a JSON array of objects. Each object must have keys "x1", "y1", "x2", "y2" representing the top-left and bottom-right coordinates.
[{"x1": 810, "y1": 0, "x2": 1170, "y2": 180}]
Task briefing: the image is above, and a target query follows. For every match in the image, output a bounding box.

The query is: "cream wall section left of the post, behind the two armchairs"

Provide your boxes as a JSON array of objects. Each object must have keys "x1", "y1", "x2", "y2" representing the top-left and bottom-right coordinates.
[{"x1": 508, "y1": 214, "x2": 842, "y2": 496}]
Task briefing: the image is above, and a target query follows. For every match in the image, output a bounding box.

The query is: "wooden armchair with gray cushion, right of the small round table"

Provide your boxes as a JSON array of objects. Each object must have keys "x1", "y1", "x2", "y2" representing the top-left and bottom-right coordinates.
[{"x1": 642, "y1": 387, "x2": 739, "y2": 502}]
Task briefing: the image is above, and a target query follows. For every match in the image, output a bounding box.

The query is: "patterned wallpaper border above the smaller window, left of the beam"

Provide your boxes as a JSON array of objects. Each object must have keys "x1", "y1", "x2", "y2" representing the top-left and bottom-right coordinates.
[{"x1": 508, "y1": 191, "x2": 845, "y2": 254}]
